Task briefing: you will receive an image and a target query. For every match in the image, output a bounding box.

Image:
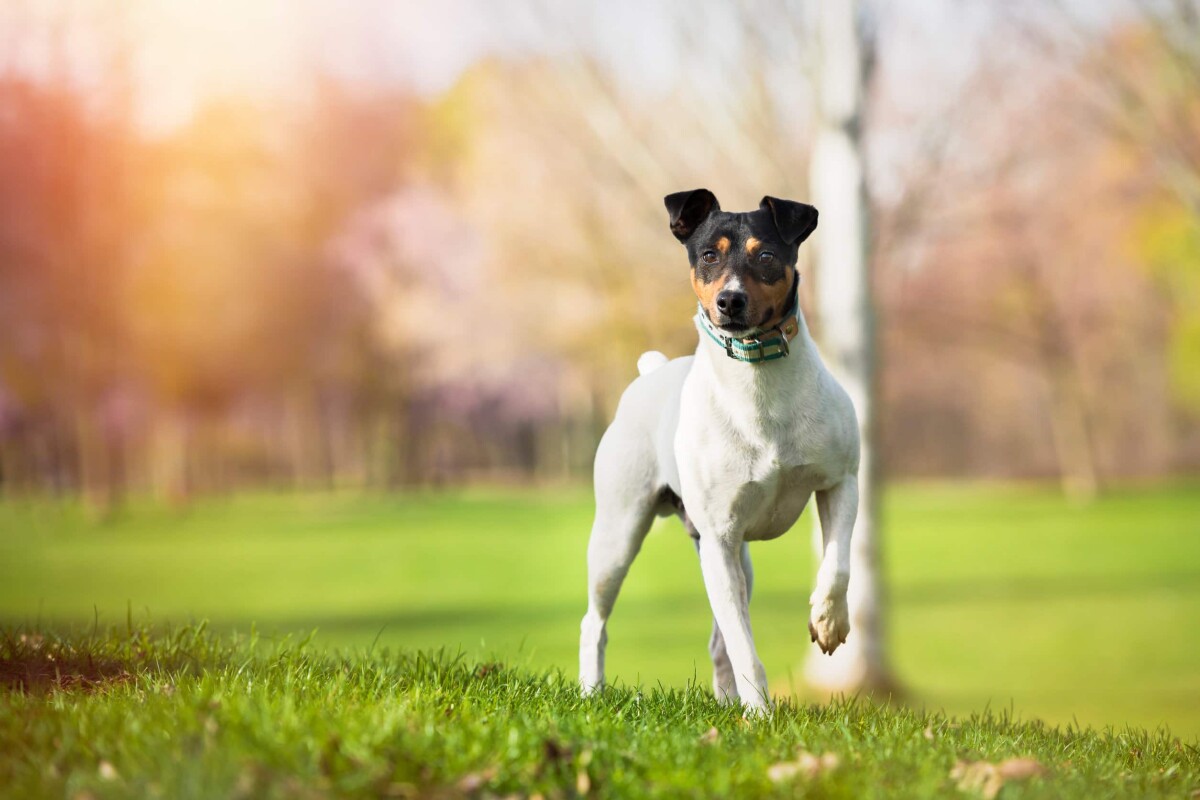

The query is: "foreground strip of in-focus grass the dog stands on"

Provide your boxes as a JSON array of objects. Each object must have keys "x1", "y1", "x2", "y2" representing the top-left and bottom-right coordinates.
[{"x1": 0, "y1": 625, "x2": 1200, "y2": 800}]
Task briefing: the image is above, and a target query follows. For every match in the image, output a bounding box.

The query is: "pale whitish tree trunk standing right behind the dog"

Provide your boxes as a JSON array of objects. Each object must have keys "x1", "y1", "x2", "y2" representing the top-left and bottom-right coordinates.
[{"x1": 805, "y1": 0, "x2": 894, "y2": 692}]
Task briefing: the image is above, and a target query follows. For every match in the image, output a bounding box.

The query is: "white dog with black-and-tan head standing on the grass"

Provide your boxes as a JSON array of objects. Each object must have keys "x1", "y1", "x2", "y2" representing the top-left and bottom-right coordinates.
[{"x1": 580, "y1": 188, "x2": 859, "y2": 711}]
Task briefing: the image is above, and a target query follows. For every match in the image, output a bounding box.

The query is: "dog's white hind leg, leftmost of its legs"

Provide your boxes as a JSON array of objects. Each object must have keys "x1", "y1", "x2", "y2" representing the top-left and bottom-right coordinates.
[{"x1": 580, "y1": 498, "x2": 654, "y2": 694}]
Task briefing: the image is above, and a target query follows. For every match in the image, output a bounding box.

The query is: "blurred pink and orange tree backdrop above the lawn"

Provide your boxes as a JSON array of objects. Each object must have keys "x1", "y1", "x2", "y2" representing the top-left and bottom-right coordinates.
[{"x1": 0, "y1": 0, "x2": 1200, "y2": 513}]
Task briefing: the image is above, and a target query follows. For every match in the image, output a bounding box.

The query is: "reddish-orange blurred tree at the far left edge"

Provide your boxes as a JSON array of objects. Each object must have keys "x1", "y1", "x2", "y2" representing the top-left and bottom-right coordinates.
[{"x1": 0, "y1": 10, "x2": 137, "y2": 515}]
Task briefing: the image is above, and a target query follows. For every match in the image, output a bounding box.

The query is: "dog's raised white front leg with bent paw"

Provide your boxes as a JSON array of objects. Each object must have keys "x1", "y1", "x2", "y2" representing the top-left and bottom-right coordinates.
[{"x1": 809, "y1": 475, "x2": 858, "y2": 654}]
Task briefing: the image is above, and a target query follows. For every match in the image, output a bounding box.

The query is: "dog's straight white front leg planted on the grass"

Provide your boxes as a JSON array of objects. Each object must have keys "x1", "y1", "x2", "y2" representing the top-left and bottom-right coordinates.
[{"x1": 700, "y1": 534, "x2": 770, "y2": 711}]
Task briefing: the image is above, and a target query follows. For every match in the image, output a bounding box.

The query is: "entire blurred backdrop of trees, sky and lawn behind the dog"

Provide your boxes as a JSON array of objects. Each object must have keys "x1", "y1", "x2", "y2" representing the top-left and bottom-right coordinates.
[{"x1": 0, "y1": 0, "x2": 1200, "y2": 738}]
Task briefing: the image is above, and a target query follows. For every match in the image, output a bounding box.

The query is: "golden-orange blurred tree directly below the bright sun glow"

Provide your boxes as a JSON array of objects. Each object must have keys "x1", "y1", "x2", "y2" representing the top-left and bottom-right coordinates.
[{"x1": 122, "y1": 101, "x2": 316, "y2": 501}]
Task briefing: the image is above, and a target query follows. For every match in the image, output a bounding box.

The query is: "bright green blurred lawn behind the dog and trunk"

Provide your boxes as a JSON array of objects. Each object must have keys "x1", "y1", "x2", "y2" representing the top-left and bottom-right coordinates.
[{"x1": 0, "y1": 483, "x2": 1200, "y2": 740}]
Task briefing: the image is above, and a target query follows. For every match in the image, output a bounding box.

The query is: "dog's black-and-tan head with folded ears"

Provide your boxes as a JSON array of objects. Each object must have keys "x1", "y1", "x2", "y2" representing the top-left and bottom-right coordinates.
[{"x1": 664, "y1": 188, "x2": 817, "y2": 336}]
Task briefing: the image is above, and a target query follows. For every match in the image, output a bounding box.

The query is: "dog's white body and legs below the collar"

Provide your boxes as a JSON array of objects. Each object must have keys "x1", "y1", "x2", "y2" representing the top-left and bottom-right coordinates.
[{"x1": 580, "y1": 313, "x2": 859, "y2": 709}]
